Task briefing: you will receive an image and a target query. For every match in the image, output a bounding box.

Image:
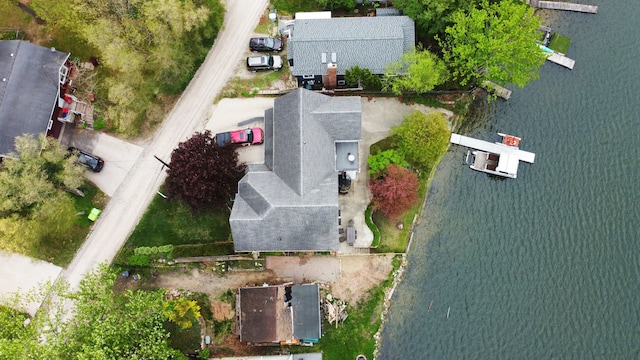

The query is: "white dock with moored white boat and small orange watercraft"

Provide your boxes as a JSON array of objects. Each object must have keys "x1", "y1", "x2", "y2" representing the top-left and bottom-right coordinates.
[{"x1": 450, "y1": 133, "x2": 536, "y2": 179}]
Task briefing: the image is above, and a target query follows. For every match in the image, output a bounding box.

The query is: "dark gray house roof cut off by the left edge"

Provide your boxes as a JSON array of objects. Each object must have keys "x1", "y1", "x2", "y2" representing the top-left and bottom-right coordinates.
[{"x1": 0, "y1": 40, "x2": 69, "y2": 156}]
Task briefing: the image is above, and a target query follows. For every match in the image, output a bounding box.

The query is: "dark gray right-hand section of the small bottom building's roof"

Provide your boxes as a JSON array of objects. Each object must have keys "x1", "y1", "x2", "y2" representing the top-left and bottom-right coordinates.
[{"x1": 291, "y1": 284, "x2": 322, "y2": 343}]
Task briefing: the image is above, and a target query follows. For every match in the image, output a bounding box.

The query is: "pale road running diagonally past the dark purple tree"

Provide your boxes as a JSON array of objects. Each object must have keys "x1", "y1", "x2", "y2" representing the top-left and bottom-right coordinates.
[{"x1": 62, "y1": 0, "x2": 267, "y2": 289}]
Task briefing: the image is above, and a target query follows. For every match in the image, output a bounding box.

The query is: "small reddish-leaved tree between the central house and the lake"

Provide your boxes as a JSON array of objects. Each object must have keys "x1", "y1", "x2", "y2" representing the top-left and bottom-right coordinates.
[{"x1": 369, "y1": 164, "x2": 420, "y2": 220}]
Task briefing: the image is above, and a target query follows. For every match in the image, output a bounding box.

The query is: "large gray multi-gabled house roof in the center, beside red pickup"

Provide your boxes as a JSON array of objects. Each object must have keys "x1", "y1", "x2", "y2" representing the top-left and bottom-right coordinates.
[{"x1": 229, "y1": 89, "x2": 362, "y2": 252}]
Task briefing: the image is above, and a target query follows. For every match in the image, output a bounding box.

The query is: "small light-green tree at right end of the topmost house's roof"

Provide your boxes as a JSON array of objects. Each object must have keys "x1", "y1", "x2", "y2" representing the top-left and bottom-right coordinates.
[{"x1": 384, "y1": 48, "x2": 449, "y2": 95}]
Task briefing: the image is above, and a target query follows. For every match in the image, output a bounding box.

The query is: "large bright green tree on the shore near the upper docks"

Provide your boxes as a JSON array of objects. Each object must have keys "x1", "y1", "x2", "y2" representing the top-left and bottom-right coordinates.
[{"x1": 438, "y1": 0, "x2": 545, "y2": 87}]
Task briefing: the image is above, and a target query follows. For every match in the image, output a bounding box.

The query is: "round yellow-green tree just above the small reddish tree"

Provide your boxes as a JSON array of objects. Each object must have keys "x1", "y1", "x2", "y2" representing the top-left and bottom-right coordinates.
[{"x1": 391, "y1": 110, "x2": 450, "y2": 169}]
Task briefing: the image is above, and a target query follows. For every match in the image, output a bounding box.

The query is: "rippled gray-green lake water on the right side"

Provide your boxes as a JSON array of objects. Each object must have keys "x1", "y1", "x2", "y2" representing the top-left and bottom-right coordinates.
[{"x1": 380, "y1": 0, "x2": 640, "y2": 359}]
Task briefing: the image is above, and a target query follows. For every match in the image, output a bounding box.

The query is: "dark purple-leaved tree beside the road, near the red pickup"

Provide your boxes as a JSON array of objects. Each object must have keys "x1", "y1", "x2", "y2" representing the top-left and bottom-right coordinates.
[{"x1": 165, "y1": 130, "x2": 246, "y2": 210}]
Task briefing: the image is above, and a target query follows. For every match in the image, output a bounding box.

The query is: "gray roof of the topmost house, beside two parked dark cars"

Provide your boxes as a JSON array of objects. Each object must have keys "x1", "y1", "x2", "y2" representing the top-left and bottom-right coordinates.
[{"x1": 287, "y1": 16, "x2": 416, "y2": 76}]
